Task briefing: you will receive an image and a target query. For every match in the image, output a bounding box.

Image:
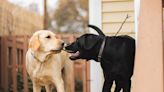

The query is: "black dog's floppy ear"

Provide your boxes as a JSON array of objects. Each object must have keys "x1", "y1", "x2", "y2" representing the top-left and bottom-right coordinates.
[{"x1": 82, "y1": 34, "x2": 99, "y2": 50}]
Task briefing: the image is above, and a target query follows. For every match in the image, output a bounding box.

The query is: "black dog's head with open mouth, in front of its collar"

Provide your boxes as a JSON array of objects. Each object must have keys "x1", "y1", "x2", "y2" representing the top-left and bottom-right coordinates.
[{"x1": 65, "y1": 34, "x2": 101, "y2": 60}]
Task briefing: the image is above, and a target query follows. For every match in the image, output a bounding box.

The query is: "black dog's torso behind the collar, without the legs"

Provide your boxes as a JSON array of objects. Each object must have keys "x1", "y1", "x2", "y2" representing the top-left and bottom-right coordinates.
[{"x1": 101, "y1": 35, "x2": 135, "y2": 78}]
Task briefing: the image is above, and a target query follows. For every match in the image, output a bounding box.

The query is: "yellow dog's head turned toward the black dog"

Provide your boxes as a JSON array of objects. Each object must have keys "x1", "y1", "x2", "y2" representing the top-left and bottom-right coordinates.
[{"x1": 29, "y1": 30, "x2": 64, "y2": 53}]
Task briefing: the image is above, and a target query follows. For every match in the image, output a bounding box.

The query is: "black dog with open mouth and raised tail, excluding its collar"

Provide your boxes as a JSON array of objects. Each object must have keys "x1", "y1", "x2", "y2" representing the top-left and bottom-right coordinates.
[{"x1": 66, "y1": 25, "x2": 135, "y2": 92}]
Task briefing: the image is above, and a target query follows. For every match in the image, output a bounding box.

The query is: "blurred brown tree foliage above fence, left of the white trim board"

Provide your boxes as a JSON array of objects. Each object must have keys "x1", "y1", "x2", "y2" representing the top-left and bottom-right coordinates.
[{"x1": 49, "y1": 0, "x2": 88, "y2": 33}]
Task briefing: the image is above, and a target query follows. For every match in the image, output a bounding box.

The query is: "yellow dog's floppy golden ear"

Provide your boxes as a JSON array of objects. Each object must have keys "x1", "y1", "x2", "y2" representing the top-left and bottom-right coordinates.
[{"x1": 29, "y1": 35, "x2": 40, "y2": 51}]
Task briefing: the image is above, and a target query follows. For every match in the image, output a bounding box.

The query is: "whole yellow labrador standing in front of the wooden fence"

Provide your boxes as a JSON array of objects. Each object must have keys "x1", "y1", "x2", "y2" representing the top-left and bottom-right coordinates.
[{"x1": 26, "y1": 30, "x2": 73, "y2": 92}]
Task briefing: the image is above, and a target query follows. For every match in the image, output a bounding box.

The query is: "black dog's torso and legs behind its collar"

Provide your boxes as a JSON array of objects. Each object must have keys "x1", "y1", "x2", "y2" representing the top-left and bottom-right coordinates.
[{"x1": 101, "y1": 35, "x2": 135, "y2": 92}]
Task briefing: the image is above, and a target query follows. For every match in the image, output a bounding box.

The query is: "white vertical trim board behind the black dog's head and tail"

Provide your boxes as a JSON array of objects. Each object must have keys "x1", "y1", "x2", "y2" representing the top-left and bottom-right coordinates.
[{"x1": 89, "y1": 0, "x2": 103, "y2": 92}]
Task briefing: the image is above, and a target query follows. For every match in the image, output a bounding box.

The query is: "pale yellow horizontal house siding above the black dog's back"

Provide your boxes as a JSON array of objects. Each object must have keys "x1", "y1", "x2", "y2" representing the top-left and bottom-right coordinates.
[{"x1": 102, "y1": 0, "x2": 135, "y2": 37}]
